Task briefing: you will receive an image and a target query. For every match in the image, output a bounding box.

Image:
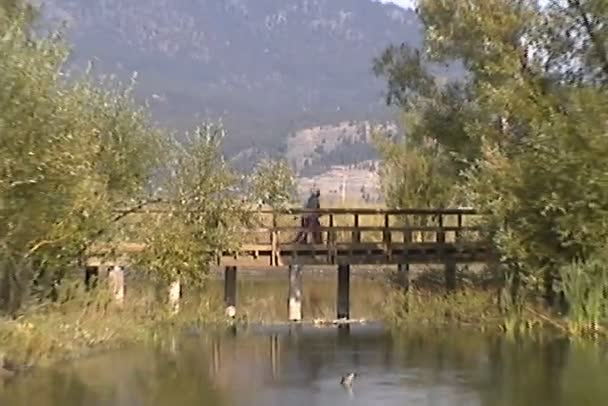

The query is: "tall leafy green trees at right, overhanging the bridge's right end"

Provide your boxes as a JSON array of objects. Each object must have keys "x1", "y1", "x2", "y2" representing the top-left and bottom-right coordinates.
[{"x1": 376, "y1": 0, "x2": 608, "y2": 324}]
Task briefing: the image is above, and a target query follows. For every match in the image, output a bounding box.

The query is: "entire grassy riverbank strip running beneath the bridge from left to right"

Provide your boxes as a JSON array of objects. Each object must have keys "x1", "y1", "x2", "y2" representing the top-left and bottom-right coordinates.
[{"x1": 0, "y1": 267, "x2": 607, "y2": 377}]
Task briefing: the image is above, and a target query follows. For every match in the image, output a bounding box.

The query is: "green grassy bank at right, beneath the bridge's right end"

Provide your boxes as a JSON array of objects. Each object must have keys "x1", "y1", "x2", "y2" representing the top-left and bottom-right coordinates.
[{"x1": 380, "y1": 267, "x2": 608, "y2": 338}]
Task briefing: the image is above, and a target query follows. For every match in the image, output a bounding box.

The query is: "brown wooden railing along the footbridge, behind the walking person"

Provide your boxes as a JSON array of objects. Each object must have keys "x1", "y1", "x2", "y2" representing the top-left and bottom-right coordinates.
[{"x1": 89, "y1": 208, "x2": 484, "y2": 263}]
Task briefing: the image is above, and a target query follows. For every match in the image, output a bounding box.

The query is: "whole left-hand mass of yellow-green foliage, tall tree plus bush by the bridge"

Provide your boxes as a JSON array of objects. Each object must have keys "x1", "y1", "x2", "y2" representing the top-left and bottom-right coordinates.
[{"x1": 0, "y1": 17, "x2": 288, "y2": 312}]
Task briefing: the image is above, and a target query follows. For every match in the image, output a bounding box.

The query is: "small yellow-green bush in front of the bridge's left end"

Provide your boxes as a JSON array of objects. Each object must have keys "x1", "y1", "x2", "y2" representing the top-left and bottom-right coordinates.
[{"x1": 137, "y1": 125, "x2": 248, "y2": 282}]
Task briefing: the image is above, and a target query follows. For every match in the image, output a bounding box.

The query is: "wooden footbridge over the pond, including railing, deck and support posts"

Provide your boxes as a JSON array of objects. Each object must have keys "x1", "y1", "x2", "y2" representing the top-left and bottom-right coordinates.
[{"x1": 89, "y1": 208, "x2": 492, "y2": 320}]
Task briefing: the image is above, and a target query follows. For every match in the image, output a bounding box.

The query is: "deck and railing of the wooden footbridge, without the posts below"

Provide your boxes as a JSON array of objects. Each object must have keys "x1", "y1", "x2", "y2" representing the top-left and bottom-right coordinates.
[{"x1": 218, "y1": 209, "x2": 488, "y2": 267}]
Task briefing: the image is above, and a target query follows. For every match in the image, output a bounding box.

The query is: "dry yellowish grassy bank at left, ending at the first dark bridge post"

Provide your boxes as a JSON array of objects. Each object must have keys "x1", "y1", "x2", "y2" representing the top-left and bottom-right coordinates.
[{"x1": 0, "y1": 280, "x2": 226, "y2": 374}]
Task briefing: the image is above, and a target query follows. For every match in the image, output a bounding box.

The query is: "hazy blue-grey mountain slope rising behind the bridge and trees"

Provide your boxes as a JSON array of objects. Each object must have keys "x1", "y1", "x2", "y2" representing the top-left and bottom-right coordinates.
[{"x1": 43, "y1": 0, "x2": 421, "y2": 154}]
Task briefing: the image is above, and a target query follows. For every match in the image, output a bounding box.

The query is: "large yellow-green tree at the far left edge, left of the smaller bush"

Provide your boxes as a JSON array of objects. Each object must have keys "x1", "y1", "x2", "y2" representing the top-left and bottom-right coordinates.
[{"x1": 0, "y1": 19, "x2": 160, "y2": 308}]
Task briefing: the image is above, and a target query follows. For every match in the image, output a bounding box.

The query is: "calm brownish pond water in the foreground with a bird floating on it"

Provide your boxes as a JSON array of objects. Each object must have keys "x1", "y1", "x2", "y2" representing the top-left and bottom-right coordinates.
[{"x1": 0, "y1": 274, "x2": 608, "y2": 406}]
